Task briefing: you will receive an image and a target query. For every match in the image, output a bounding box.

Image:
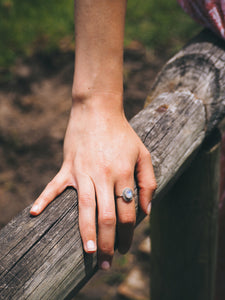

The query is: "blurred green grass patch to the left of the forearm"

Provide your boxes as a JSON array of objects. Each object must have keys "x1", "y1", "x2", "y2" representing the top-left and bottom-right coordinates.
[{"x1": 0, "y1": 0, "x2": 74, "y2": 68}]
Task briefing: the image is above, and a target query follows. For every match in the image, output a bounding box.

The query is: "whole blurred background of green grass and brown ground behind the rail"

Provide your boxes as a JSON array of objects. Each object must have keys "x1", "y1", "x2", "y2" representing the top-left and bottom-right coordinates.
[{"x1": 0, "y1": 0, "x2": 201, "y2": 300}]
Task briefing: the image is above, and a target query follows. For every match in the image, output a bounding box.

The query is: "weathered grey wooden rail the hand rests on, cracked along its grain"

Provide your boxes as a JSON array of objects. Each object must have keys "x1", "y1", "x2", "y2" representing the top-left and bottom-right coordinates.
[{"x1": 0, "y1": 29, "x2": 225, "y2": 300}]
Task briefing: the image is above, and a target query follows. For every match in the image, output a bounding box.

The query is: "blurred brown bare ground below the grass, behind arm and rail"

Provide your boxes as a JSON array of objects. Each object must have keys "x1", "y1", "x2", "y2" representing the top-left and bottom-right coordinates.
[{"x1": 0, "y1": 43, "x2": 166, "y2": 300}]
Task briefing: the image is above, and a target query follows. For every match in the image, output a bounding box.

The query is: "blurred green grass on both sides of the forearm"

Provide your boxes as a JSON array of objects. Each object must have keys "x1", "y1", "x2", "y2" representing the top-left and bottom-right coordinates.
[{"x1": 0, "y1": 0, "x2": 199, "y2": 71}]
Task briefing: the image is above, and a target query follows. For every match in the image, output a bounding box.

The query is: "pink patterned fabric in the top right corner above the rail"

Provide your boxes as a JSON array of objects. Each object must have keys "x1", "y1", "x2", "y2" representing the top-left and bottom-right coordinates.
[{"x1": 178, "y1": 0, "x2": 225, "y2": 39}]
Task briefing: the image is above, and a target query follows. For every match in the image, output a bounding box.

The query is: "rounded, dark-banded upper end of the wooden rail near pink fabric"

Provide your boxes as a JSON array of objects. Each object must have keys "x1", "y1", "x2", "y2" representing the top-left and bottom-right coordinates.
[{"x1": 146, "y1": 30, "x2": 225, "y2": 131}]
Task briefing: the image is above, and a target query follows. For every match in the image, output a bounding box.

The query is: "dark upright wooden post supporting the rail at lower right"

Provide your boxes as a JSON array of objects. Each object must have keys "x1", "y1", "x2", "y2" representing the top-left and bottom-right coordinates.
[{"x1": 150, "y1": 131, "x2": 220, "y2": 300}]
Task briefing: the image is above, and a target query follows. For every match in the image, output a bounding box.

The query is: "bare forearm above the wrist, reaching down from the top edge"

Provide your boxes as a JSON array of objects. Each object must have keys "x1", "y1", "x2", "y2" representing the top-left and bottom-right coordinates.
[{"x1": 72, "y1": 0, "x2": 126, "y2": 105}]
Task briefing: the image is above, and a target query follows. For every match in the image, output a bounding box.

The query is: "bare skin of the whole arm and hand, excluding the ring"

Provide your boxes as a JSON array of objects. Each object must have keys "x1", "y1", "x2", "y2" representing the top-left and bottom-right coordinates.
[{"x1": 30, "y1": 0, "x2": 156, "y2": 270}]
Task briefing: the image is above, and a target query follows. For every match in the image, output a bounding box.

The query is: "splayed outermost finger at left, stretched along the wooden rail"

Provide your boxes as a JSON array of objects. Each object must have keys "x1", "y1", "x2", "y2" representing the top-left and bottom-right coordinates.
[{"x1": 30, "y1": 169, "x2": 74, "y2": 216}]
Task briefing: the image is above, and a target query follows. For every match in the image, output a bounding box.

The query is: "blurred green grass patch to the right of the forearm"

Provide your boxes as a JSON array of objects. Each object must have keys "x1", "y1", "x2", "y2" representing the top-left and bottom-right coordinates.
[{"x1": 125, "y1": 0, "x2": 200, "y2": 55}]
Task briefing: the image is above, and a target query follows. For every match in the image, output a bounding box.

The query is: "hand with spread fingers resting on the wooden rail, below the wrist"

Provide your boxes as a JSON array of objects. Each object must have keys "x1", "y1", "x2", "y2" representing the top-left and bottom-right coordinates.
[{"x1": 30, "y1": 96, "x2": 156, "y2": 269}]
